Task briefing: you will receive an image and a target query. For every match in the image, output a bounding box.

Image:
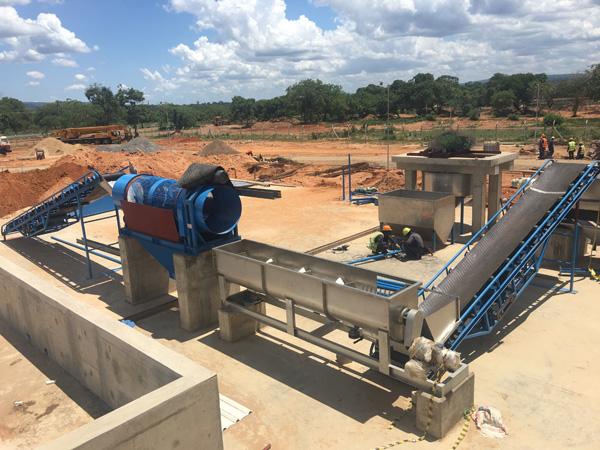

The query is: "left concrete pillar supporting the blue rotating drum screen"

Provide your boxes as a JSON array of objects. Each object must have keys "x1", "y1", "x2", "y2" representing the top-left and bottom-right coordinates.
[{"x1": 119, "y1": 236, "x2": 169, "y2": 305}]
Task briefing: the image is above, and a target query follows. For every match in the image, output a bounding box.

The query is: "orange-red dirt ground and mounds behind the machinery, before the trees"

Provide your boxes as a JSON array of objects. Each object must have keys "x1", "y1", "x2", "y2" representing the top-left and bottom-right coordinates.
[{"x1": 0, "y1": 137, "x2": 548, "y2": 221}]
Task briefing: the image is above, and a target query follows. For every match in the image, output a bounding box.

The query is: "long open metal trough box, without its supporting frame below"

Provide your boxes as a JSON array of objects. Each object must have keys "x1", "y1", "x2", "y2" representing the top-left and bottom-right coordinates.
[{"x1": 214, "y1": 240, "x2": 421, "y2": 345}]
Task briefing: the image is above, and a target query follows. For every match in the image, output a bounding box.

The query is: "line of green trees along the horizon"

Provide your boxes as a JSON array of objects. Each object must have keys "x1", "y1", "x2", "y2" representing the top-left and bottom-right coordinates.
[{"x1": 0, "y1": 64, "x2": 600, "y2": 134}]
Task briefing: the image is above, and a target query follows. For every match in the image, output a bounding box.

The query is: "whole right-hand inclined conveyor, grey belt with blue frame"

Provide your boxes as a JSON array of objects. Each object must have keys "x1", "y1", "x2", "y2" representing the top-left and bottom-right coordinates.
[{"x1": 419, "y1": 162, "x2": 600, "y2": 349}]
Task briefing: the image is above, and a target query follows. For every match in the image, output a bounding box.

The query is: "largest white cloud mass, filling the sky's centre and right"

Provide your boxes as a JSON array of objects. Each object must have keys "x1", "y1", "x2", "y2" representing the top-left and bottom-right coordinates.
[{"x1": 150, "y1": 0, "x2": 600, "y2": 100}]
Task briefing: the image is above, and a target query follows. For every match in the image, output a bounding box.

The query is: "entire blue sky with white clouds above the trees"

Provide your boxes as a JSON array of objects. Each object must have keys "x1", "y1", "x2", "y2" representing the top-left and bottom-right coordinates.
[{"x1": 0, "y1": 0, "x2": 600, "y2": 104}]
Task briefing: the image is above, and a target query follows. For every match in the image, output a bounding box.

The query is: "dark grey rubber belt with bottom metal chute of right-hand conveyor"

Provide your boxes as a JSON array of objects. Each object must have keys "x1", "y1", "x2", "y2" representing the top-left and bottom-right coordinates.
[{"x1": 419, "y1": 163, "x2": 586, "y2": 340}]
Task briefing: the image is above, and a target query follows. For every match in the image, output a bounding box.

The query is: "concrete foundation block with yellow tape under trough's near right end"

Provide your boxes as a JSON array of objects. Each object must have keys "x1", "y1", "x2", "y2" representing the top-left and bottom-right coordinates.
[{"x1": 412, "y1": 373, "x2": 475, "y2": 439}]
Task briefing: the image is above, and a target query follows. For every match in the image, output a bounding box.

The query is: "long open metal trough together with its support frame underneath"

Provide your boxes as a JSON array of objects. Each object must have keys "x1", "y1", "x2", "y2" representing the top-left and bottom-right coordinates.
[{"x1": 213, "y1": 240, "x2": 469, "y2": 397}]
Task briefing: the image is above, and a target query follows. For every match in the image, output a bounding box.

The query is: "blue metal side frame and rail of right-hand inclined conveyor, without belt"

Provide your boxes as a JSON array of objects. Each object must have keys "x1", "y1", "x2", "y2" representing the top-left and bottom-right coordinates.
[{"x1": 423, "y1": 161, "x2": 600, "y2": 349}]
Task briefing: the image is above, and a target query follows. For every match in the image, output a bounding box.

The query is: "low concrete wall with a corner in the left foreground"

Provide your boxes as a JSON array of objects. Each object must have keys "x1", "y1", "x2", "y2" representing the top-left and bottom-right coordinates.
[{"x1": 0, "y1": 257, "x2": 223, "y2": 450}]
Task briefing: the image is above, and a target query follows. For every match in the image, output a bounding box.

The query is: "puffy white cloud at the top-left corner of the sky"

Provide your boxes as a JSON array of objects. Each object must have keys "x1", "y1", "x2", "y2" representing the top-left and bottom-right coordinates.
[{"x1": 0, "y1": 5, "x2": 90, "y2": 63}]
